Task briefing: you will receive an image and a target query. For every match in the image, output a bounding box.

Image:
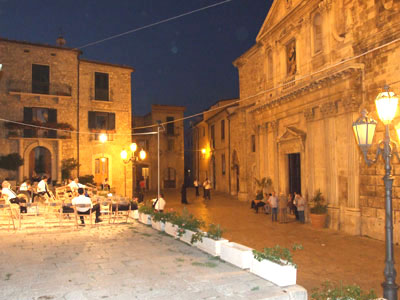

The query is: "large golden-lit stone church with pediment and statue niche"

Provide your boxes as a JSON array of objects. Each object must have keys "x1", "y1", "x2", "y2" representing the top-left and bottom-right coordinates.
[{"x1": 230, "y1": 0, "x2": 400, "y2": 242}]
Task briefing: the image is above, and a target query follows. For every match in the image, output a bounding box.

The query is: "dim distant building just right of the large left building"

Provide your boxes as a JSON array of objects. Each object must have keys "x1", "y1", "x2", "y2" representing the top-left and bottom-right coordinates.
[{"x1": 132, "y1": 104, "x2": 185, "y2": 190}]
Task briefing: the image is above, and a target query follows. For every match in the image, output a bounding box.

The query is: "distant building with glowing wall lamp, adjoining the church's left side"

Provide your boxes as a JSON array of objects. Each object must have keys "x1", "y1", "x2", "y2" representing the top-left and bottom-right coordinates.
[{"x1": 191, "y1": 99, "x2": 238, "y2": 194}]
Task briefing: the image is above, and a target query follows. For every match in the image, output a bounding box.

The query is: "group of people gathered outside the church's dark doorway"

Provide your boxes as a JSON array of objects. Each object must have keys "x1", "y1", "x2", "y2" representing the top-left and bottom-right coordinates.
[{"x1": 251, "y1": 192, "x2": 305, "y2": 224}]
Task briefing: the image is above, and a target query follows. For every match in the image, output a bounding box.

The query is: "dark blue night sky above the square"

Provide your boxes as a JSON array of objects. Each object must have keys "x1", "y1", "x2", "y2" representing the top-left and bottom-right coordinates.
[{"x1": 0, "y1": 0, "x2": 272, "y2": 115}]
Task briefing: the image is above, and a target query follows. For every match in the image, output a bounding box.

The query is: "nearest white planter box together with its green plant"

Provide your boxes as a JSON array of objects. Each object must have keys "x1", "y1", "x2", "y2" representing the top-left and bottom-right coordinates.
[{"x1": 250, "y1": 245, "x2": 303, "y2": 286}]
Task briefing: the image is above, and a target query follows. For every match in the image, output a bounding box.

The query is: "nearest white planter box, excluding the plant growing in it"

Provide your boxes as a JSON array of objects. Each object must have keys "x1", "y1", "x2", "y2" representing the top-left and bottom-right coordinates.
[{"x1": 250, "y1": 257, "x2": 297, "y2": 286}]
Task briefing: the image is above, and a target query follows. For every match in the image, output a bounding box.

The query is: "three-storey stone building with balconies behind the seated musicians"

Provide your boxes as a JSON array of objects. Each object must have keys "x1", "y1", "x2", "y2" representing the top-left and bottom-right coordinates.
[{"x1": 0, "y1": 39, "x2": 133, "y2": 194}]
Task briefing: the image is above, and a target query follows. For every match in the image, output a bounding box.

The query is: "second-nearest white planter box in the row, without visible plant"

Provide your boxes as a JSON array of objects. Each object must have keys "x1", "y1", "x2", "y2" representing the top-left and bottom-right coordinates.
[{"x1": 220, "y1": 242, "x2": 253, "y2": 269}]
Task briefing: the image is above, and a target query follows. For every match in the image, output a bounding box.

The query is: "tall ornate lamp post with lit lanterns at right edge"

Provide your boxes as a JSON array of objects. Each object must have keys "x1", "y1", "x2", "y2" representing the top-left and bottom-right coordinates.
[{"x1": 353, "y1": 86, "x2": 400, "y2": 300}]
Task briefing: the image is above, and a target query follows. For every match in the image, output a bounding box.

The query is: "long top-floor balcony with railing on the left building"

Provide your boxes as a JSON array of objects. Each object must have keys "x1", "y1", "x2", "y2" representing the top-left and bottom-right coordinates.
[{"x1": 7, "y1": 80, "x2": 72, "y2": 97}]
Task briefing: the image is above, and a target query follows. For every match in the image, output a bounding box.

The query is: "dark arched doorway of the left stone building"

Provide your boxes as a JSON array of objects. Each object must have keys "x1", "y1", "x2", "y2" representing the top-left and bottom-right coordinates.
[{"x1": 29, "y1": 146, "x2": 51, "y2": 179}]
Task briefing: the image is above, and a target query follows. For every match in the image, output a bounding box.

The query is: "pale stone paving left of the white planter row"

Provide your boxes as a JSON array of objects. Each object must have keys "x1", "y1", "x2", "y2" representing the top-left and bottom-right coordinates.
[{"x1": 0, "y1": 218, "x2": 306, "y2": 300}]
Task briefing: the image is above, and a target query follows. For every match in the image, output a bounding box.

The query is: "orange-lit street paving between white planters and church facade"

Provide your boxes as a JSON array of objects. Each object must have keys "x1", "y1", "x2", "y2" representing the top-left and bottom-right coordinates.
[{"x1": 150, "y1": 188, "x2": 400, "y2": 296}]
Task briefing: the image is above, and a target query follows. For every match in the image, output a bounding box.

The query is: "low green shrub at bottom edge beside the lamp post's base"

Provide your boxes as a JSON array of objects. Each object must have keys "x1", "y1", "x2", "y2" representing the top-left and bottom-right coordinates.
[{"x1": 311, "y1": 281, "x2": 377, "y2": 300}]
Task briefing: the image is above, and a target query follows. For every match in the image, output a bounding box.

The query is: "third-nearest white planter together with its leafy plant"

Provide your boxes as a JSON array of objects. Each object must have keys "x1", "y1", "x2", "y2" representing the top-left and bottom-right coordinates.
[{"x1": 196, "y1": 224, "x2": 229, "y2": 256}]
